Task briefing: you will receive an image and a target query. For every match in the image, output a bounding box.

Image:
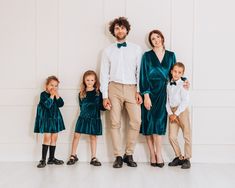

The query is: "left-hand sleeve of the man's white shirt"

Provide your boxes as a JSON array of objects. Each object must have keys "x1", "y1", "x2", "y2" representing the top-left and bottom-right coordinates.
[{"x1": 100, "y1": 50, "x2": 110, "y2": 98}]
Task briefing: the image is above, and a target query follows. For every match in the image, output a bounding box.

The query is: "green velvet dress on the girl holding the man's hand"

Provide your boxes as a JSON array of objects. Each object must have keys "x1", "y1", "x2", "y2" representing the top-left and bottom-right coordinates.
[{"x1": 75, "y1": 89, "x2": 105, "y2": 135}]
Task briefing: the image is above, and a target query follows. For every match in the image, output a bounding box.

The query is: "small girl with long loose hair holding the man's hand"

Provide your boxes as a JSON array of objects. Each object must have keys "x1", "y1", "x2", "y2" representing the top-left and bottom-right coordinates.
[{"x1": 67, "y1": 70, "x2": 105, "y2": 166}]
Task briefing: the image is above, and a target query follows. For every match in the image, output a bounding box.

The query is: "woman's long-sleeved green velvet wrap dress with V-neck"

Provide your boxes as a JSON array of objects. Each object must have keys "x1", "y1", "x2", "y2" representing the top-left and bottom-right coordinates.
[{"x1": 140, "y1": 50, "x2": 176, "y2": 135}]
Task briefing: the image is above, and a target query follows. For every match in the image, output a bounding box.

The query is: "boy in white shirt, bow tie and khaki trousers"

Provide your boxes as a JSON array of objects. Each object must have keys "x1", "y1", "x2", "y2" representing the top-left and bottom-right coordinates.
[{"x1": 166, "y1": 62, "x2": 192, "y2": 169}]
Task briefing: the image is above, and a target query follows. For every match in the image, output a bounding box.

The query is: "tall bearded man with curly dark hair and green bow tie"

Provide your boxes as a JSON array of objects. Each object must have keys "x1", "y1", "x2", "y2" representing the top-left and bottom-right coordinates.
[{"x1": 100, "y1": 17, "x2": 142, "y2": 168}]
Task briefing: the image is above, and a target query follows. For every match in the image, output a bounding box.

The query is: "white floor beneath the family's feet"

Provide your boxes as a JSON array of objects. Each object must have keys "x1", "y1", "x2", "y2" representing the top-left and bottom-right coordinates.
[{"x1": 0, "y1": 162, "x2": 235, "y2": 188}]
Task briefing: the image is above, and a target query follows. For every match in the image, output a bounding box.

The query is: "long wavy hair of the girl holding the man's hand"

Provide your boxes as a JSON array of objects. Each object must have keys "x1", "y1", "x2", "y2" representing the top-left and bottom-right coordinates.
[{"x1": 79, "y1": 70, "x2": 100, "y2": 99}]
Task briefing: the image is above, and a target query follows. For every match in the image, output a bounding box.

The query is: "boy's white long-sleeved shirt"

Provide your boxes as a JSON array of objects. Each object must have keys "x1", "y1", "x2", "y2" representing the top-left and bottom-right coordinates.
[{"x1": 166, "y1": 79, "x2": 189, "y2": 116}]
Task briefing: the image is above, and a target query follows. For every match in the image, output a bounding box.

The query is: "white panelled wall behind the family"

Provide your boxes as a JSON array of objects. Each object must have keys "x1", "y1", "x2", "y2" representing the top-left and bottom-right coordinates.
[{"x1": 0, "y1": 0, "x2": 235, "y2": 163}]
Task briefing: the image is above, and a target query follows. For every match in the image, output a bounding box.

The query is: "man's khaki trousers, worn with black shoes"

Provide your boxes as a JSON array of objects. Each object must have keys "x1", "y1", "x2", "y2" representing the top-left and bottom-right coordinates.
[{"x1": 108, "y1": 82, "x2": 141, "y2": 157}]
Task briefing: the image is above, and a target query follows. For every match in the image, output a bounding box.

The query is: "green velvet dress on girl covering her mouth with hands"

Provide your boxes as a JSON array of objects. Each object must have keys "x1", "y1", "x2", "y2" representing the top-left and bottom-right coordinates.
[{"x1": 34, "y1": 91, "x2": 65, "y2": 133}]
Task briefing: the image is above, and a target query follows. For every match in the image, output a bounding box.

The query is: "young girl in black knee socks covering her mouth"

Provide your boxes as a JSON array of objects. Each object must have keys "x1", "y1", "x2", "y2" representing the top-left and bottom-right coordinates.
[{"x1": 34, "y1": 76, "x2": 65, "y2": 168}]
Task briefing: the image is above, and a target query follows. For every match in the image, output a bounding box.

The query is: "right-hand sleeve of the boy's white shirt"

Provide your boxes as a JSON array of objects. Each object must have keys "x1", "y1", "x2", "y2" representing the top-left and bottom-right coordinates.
[{"x1": 175, "y1": 86, "x2": 189, "y2": 116}]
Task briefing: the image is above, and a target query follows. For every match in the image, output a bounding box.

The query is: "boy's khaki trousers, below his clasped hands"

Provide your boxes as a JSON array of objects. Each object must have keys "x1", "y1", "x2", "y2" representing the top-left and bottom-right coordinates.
[{"x1": 169, "y1": 107, "x2": 192, "y2": 159}]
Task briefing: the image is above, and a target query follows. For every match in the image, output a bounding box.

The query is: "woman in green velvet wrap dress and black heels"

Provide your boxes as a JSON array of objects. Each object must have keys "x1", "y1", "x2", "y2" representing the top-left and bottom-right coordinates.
[{"x1": 140, "y1": 30, "x2": 176, "y2": 168}]
